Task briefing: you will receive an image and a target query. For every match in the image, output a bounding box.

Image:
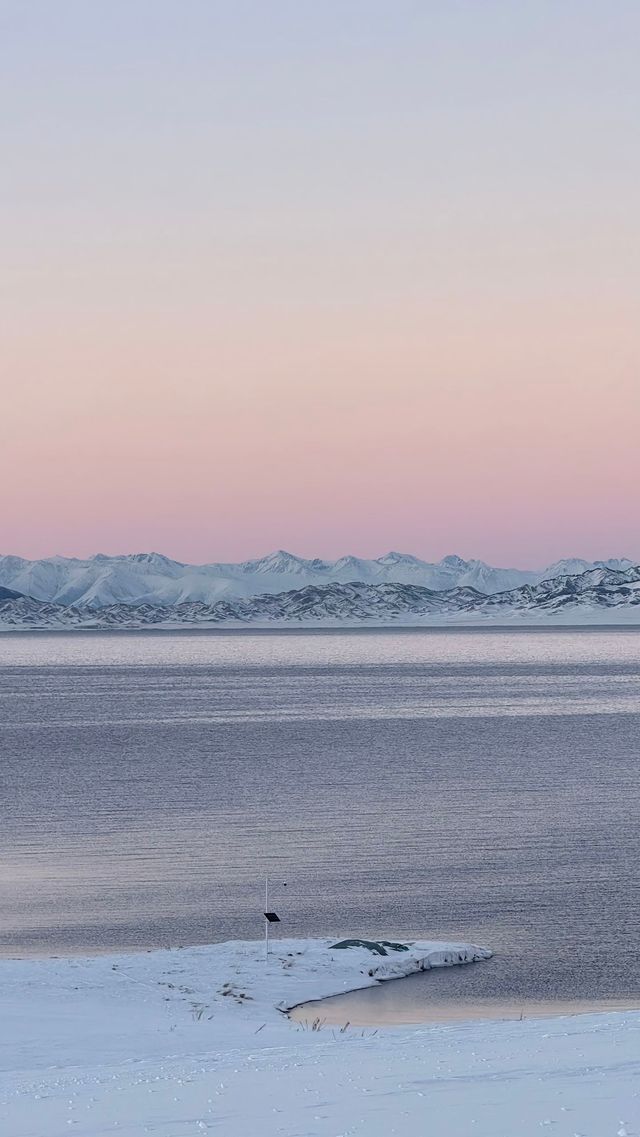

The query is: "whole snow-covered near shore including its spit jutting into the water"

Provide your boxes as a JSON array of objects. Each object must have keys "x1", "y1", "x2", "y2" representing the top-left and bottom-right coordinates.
[{"x1": 0, "y1": 940, "x2": 640, "y2": 1137}]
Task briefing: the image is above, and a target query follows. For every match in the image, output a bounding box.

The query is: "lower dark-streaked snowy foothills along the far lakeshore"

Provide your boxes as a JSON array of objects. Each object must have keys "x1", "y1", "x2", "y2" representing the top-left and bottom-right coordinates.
[{"x1": 0, "y1": 566, "x2": 640, "y2": 630}]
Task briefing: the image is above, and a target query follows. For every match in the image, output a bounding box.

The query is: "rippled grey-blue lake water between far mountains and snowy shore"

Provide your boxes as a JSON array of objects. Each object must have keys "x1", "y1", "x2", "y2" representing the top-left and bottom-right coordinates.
[{"x1": 0, "y1": 630, "x2": 640, "y2": 999}]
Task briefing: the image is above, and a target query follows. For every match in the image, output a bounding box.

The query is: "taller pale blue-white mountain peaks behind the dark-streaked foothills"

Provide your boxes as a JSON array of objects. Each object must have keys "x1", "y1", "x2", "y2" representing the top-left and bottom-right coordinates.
[{"x1": 0, "y1": 550, "x2": 632, "y2": 608}]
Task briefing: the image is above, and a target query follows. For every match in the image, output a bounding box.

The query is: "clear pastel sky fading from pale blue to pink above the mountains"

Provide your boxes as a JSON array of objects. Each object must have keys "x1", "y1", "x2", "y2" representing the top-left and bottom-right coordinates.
[{"x1": 0, "y1": 0, "x2": 640, "y2": 565}]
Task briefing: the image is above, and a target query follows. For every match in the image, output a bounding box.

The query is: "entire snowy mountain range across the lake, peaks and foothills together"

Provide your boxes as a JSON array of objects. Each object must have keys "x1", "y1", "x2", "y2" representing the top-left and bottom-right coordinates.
[{"x1": 0, "y1": 553, "x2": 640, "y2": 630}]
